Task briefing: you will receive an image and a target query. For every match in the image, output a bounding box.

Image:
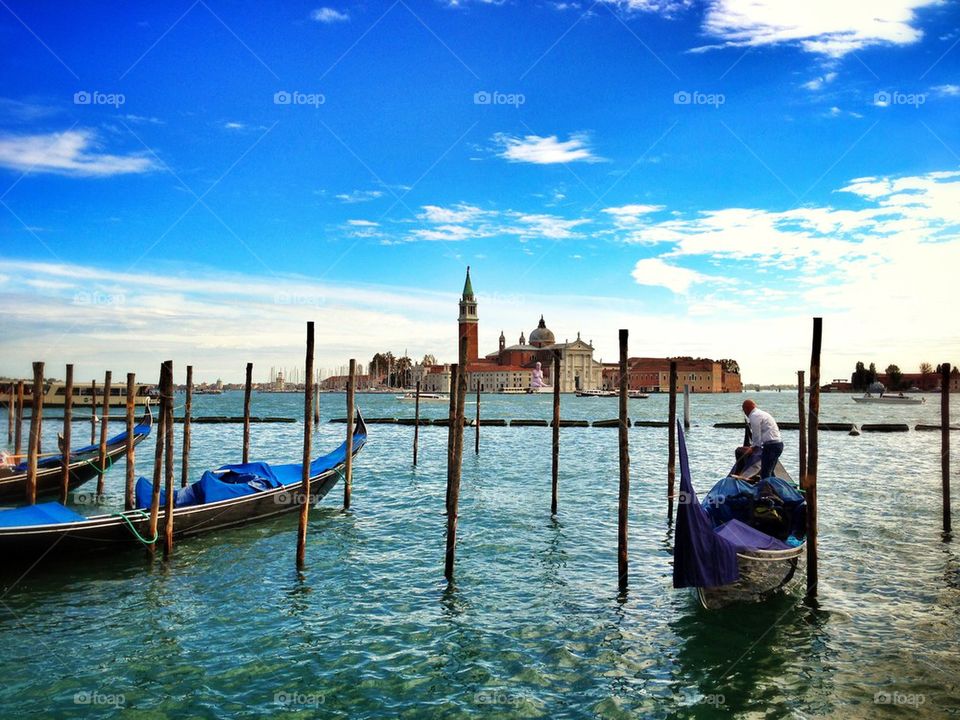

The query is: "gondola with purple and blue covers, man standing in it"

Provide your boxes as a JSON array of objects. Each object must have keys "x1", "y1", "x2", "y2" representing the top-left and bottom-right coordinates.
[{"x1": 673, "y1": 423, "x2": 806, "y2": 610}]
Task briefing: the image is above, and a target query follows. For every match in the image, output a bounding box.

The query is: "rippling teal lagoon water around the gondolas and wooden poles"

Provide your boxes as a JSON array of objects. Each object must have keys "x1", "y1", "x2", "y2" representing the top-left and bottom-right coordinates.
[{"x1": 0, "y1": 392, "x2": 960, "y2": 718}]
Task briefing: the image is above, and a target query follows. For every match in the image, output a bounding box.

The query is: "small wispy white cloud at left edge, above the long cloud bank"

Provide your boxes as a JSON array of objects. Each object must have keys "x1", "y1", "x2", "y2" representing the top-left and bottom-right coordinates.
[{"x1": 0, "y1": 130, "x2": 155, "y2": 177}]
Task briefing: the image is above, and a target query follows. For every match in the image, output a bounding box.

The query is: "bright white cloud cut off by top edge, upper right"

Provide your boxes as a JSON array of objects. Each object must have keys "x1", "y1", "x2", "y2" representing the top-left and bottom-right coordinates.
[{"x1": 704, "y1": 0, "x2": 939, "y2": 58}]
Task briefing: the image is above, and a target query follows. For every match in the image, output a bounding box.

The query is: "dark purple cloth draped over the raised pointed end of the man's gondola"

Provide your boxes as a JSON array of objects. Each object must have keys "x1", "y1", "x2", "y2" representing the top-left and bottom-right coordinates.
[{"x1": 673, "y1": 421, "x2": 740, "y2": 588}]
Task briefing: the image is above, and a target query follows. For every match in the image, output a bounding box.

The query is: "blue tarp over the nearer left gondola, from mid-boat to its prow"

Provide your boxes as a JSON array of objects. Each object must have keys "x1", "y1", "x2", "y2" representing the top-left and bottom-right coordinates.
[{"x1": 135, "y1": 428, "x2": 366, "y2": 510}]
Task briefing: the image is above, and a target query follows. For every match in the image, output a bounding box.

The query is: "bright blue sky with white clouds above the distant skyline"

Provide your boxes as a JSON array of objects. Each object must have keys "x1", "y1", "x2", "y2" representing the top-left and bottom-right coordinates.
[{"x1": 0, "y1": 0, "x2": 960, "y2": 382}]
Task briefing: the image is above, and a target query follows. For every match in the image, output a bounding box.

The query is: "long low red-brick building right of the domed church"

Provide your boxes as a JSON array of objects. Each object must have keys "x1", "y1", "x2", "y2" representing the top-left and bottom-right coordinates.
[{"x1": 603, "y1": 357, "x2": 743, "y2": 393}]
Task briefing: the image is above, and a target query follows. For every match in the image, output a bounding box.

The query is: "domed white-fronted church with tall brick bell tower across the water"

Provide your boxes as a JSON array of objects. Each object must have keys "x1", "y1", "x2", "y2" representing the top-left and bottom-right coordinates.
[{"x1": 450, "y1": 267, "x2": 603, "y2": 392}]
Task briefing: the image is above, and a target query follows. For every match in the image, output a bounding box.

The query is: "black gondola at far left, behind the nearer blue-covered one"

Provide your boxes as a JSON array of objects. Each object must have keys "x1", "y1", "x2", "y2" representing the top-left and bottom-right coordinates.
[{"x1": 0, "y1": 408, "x2": 153, "y2": 505}]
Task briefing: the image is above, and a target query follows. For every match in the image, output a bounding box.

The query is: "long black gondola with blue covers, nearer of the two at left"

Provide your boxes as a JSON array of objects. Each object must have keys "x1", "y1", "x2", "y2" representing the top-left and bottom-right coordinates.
[{"x1": 0, "y1": 412, "x2": 367, "y2": 561}]
